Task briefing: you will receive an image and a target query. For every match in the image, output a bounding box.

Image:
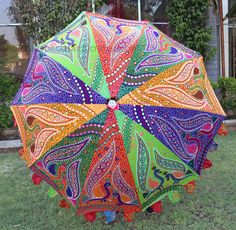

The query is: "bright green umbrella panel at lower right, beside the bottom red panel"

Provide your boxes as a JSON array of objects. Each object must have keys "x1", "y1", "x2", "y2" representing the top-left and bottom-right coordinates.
[{"x1": 116, "y1": 111, "x2": 198, "y2": 209}]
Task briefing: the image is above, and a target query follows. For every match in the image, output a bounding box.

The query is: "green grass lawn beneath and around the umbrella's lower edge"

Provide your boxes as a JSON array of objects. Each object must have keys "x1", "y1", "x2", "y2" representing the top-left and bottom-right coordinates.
[{"x1": 0, "y1": 132, "x2": 236, "y2": 230}]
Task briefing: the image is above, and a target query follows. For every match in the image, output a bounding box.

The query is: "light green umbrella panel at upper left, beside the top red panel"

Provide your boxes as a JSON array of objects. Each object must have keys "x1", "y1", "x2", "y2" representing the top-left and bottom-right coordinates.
[{"x1": 38, "y1": 13, "x2": 110, "y2": 98}]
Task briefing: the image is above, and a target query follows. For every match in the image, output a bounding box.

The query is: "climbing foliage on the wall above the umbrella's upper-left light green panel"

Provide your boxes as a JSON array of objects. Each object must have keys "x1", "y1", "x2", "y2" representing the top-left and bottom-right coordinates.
[{"x1": 9, "y1": 0, "x2": 105, "y2": 43}]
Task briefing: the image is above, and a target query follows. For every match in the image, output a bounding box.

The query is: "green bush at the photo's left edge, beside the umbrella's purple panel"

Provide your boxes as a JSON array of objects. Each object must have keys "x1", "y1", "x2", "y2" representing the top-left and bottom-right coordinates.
[{"x1": 0, "y1": 74, "x2": 19, "y2": 129}]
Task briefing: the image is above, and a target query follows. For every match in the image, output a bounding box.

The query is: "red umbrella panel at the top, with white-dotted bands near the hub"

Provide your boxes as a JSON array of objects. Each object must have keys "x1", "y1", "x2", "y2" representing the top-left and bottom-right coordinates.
[{"x1": 88, "y1": 12, "x2": 145, "y2": 97}]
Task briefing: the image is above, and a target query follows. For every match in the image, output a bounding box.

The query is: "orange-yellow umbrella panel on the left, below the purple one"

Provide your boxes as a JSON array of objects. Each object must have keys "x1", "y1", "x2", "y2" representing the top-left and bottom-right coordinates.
[{"x1": 11, "y1": 104, "x2": 106, "y2": 166}]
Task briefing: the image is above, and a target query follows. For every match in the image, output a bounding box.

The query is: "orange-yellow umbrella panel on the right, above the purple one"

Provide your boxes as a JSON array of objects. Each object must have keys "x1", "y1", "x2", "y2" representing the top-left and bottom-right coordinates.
[{"x1": 119, "y1": 57, "x2": 225, "y2": 115}]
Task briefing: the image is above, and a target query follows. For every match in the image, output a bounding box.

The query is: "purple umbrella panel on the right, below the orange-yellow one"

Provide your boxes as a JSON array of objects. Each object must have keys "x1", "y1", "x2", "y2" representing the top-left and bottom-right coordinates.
[{"x1": 120, "y1": 105, "x2": 224, "y2": 173}]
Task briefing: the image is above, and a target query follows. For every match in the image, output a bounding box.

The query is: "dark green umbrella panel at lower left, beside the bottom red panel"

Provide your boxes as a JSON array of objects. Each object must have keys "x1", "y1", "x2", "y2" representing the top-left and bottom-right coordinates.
[{"x1": 30, "y1": 111, "x2": 107, "y2": 205}]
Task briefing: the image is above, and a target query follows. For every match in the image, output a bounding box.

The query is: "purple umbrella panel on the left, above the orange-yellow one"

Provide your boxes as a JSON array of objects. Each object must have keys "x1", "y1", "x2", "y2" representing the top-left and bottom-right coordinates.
[{"x1": 12, "y1": 49, "x2": 106, "y2": 105}]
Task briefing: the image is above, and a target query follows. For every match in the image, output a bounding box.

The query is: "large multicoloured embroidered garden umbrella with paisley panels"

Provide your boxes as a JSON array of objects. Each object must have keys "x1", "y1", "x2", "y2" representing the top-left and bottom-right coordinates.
[{"x1": 11, "y1": 12, "x2": 224, "y2": 220}]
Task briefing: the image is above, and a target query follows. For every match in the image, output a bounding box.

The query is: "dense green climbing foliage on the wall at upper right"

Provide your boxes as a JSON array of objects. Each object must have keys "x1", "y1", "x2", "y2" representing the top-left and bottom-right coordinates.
[{"x1": 167, "y1": 0, "x2": 215, "y2": 61}]
